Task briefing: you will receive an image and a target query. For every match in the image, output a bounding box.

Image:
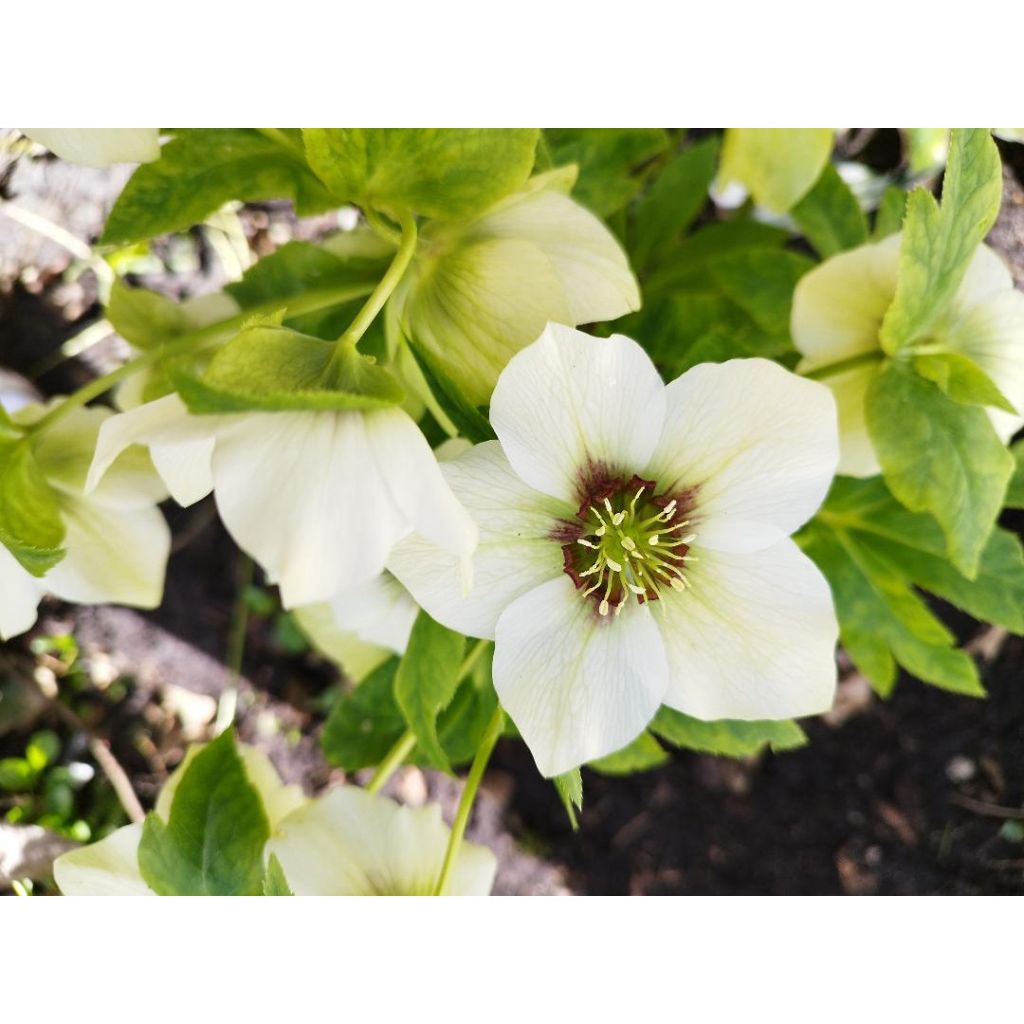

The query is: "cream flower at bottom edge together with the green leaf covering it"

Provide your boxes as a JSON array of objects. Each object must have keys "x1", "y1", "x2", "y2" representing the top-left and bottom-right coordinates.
[{"x1": 54, "y1": 733, "x2": 497, "y2": 896}]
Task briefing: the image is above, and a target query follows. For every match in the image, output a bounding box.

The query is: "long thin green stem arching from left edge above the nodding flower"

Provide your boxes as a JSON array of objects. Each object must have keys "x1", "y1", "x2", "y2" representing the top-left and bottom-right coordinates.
[{"x1": 29, "y1": 285, "x2": 371, "y2": 434}]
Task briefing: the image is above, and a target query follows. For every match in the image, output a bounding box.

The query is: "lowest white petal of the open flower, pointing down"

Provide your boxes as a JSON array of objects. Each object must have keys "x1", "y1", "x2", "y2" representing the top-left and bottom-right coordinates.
[{"x1": 494, "y1": 574, "x2": 668, "y2": 776}]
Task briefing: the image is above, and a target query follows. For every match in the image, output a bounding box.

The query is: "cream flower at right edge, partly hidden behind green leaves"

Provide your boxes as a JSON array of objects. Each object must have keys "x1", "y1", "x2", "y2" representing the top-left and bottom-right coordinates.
[{"x1": 791, "y1": 234, "x2": 1024, "y2": 476}]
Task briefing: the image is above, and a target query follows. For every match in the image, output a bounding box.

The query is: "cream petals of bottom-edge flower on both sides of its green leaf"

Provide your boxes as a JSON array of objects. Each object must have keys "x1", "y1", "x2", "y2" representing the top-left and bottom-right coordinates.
[{"x1": 53, "y1": 743, "x2": 497, "y2": 896}]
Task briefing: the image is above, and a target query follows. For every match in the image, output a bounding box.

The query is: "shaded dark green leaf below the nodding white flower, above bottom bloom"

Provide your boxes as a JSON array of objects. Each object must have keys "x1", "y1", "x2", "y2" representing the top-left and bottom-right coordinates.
[{"x1": 322, "y1": 657, "x2": 406, "y2": 771}]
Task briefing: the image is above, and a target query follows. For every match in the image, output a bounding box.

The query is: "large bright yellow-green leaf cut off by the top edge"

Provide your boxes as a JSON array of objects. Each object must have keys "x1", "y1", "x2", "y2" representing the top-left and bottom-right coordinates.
[{"x1": 303, "y1": 128, "x2": 539, "y2": 218}]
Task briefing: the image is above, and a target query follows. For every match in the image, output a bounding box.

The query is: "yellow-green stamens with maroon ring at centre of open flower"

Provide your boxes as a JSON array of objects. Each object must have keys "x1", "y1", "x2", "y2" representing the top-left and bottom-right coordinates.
[{"x1": 562, "y1": 480, "x2": 695, "y2": 615}]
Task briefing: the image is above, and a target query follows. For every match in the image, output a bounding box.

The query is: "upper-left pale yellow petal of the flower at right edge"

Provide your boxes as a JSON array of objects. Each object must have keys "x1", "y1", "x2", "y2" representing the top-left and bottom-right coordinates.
[{"x1": 790, "y1": 236, "x2": 899, "y2": 369}]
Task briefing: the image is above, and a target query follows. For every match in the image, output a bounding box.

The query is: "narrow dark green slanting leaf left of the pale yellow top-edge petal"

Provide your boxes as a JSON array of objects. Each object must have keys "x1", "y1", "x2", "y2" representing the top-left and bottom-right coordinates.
[{"x1": 630, "y1": 136, "x2": 719, "y2": 270}]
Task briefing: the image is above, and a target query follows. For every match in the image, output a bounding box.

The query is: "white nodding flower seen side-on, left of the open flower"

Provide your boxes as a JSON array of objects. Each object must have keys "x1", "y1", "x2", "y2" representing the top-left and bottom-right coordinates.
[{"x1": 87, "y1": 394, "x2": 476, "y2": 608}]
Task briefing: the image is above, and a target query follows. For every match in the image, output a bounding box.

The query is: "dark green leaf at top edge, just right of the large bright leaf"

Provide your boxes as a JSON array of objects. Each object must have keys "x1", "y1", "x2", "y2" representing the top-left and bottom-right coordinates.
[{"x1": 544, "y1": 128, "x2": 669, "y2": 217}]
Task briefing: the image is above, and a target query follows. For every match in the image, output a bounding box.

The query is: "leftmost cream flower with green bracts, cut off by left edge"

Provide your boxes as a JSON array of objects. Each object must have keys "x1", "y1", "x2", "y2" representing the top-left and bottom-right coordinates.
[{"x1": 0, "y1": 395, "x2": 171, "y2": 640}]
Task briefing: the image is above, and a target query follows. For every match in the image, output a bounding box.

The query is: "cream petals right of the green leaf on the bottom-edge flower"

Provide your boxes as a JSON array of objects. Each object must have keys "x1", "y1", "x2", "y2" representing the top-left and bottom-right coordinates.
[{"x1": 267, "y1": 785, "x2": 498, "y2": 896}]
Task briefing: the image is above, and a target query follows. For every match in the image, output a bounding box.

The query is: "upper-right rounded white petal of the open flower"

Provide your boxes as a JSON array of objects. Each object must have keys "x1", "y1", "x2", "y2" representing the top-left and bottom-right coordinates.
[{"x1": 642, "y1": 359, "x2": 839, "y2": 551}]
